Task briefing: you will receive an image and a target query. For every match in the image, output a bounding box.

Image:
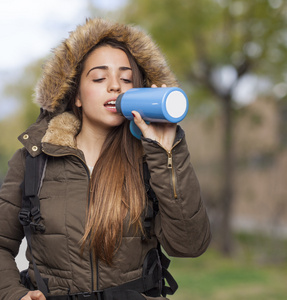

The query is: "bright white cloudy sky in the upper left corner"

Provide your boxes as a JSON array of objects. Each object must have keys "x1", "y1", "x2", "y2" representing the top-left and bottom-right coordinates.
[{"x1": 0, "y1": 0, "x2": 85, "y2": 71}]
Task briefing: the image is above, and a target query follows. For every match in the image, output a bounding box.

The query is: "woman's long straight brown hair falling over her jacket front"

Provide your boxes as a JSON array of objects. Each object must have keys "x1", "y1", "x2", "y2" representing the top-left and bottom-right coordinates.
[{"x1": 72, "y1": 39, "x2": 145, "y2": 264}]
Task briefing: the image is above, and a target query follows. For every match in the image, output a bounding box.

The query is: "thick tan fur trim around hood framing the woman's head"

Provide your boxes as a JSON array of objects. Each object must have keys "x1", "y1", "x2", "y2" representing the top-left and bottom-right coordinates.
[{"x1": 35, "y1": 19, "x2": 178, "y2": 113}]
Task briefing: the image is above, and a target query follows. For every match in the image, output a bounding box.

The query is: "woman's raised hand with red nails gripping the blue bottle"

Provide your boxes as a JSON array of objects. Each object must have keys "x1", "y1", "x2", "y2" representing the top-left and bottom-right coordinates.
[{"x1": 132, "y1": 84, "x2": 176, "y2": 151}]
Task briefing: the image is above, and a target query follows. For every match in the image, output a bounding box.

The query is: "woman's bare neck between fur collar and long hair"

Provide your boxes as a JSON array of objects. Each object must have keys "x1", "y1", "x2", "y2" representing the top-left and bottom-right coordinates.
[{"x1": 76, "y1": 124, "x2": 108, "y2": 167}]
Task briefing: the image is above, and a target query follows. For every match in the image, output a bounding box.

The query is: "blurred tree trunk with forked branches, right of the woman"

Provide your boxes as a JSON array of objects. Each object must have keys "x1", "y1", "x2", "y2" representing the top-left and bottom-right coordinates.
[{"x1": 188, "y1": 60, "x2": 248, "y2": 255}]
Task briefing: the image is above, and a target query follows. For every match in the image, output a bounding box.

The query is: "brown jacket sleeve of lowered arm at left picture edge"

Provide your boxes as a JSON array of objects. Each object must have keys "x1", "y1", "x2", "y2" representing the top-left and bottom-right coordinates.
[{"x1": 0, "y1": 150, "x2": 28, "y2": 300}]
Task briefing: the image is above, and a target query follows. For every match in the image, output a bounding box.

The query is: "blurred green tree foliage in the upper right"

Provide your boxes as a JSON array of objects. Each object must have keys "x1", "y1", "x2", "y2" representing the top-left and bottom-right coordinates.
[{"x1": 123, "y1": 0, "x2": 287, "y2": 103}]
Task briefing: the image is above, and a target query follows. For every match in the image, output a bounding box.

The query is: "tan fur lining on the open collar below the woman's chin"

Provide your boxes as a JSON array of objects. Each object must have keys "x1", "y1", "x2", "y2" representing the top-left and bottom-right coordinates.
[{"x1": 42, "y1": 112, "x2": 80, "y2": 148}]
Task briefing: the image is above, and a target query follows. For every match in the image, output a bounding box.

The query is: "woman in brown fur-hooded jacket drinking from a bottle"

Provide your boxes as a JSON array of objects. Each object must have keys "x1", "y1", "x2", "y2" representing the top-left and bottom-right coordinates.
[{"x1": 0, "y1": 19, "x2": 210, "y2": 300}]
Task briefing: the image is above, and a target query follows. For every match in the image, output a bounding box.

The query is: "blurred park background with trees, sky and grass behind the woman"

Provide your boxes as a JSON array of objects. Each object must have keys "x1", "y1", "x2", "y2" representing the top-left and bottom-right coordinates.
[{"x1": 0, "y1": 0, "x2": 287, "y2": 300}]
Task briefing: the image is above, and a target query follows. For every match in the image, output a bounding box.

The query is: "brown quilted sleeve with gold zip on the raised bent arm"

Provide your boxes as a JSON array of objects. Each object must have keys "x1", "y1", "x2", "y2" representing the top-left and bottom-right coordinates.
[{"x1": 142, "y1": 126, "x2": 211, "y2": 257}]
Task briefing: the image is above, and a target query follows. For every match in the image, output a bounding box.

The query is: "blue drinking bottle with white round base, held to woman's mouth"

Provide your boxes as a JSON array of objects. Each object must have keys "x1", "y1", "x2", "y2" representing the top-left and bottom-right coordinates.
[{"x1": 116, "y1": 87, "x2": 188, "y2": 138}]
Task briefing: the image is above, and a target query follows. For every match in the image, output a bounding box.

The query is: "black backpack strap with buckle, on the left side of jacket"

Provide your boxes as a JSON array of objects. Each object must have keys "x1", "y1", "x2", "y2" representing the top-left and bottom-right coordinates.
[{"x1": 19, "y1": 153, "x2": 48, "y2": 296}]
